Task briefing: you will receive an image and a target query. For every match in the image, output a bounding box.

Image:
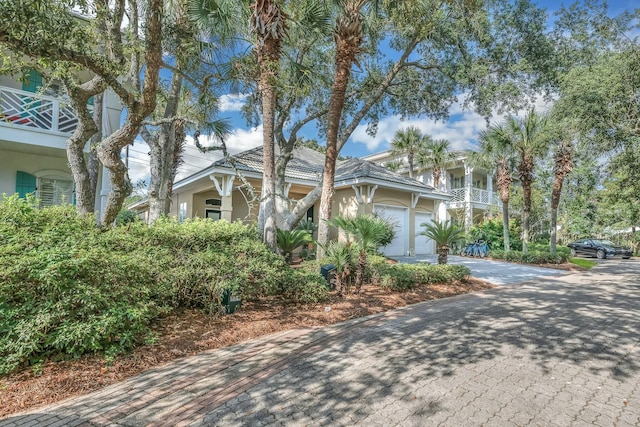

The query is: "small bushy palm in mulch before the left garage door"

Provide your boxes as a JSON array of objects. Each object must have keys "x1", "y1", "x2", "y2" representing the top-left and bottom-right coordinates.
[{"x1": 329, "y1": 215, "x2": 389, "y2": 292}]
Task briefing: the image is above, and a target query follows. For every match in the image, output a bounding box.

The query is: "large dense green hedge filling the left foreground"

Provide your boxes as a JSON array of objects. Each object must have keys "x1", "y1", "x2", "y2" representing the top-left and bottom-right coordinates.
[{"x1": 0, "y1": 196, "x2": 308, "y2": 373}]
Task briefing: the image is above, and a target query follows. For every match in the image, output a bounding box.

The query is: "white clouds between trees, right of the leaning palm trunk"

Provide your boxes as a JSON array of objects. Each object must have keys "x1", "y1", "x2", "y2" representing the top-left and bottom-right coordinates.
[{"x1": 351, "y1": 96, "x2": 551, "y2": 153}]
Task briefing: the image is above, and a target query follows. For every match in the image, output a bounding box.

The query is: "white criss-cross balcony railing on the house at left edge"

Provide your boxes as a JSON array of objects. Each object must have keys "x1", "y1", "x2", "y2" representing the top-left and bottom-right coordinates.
[{"x1": 0, "y1": 86, "x2": 85, "y2": 134}]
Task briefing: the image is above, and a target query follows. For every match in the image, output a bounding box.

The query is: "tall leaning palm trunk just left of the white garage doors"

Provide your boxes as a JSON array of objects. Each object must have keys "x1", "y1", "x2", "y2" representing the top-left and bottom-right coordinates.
[{"x1": 317, "y1": 30, "x2": 360, "y2": 259}]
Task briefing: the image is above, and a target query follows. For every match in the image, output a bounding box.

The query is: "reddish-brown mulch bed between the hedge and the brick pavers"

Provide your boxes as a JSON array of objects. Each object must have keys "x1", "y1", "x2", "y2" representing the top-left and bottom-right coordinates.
[{"x1": 0, "y1": 279, "x2": 495, "y2": 417}]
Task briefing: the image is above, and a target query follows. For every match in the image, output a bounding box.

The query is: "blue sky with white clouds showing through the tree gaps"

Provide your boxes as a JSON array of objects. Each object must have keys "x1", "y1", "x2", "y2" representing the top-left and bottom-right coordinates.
[{"x1": 129, "y1": 0, "x2": 640, "y2": 183}]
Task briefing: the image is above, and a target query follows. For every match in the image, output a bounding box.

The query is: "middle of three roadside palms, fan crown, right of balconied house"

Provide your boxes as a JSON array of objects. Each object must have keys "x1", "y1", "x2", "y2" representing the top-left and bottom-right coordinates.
[{"x1": 504, "y1": 109, "x2": 548, "y2": 254}]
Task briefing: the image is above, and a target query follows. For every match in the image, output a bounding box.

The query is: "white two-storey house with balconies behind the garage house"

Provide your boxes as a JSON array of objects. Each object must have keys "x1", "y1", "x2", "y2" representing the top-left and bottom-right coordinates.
[{"x1": 363, "y1": 151, "x2": 502, "y2": 228}]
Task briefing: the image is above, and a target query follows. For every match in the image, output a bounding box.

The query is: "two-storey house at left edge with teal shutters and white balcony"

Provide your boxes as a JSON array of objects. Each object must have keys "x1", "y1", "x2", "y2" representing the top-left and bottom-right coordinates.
[{"x1": 0, "y1": 68, "x2": 122, "y2": 214}]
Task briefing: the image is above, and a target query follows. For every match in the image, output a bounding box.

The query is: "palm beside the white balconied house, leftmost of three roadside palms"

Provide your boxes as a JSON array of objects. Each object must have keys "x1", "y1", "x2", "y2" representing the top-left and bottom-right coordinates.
[{"x1": 470, "y1": 125, "x2": 515, "y2": 251}]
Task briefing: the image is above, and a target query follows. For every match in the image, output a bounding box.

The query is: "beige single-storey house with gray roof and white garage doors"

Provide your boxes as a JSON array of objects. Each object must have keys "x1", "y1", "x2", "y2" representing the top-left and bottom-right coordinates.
[{"x1": 131, "y1": 147, "x2": 450, "y2": 256}]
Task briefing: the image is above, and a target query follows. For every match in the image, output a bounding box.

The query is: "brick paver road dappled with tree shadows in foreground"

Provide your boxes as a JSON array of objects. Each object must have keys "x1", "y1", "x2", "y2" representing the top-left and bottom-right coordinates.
[{"x1": 0, "y1": 260, "x2": 640, "y2": 427}]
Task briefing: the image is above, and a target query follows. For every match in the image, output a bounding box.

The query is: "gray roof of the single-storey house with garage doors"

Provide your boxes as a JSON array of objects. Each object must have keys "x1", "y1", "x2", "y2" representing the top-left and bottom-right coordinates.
[{"x1": 212, "y1": 147, "x2": 433, "y2": 191}]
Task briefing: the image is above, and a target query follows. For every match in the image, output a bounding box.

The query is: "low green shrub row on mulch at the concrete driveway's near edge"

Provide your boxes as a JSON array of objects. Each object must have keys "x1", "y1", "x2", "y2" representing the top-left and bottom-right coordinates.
[{"x1": 380, "y1": 264, "x2": 471, "y2": 291}]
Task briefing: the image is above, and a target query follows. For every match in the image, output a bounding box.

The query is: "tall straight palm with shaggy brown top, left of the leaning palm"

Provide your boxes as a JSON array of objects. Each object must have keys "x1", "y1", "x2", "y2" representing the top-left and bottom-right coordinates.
[{"x1": 250, "y1": 0, "x2": 287, "y2": 251}]
